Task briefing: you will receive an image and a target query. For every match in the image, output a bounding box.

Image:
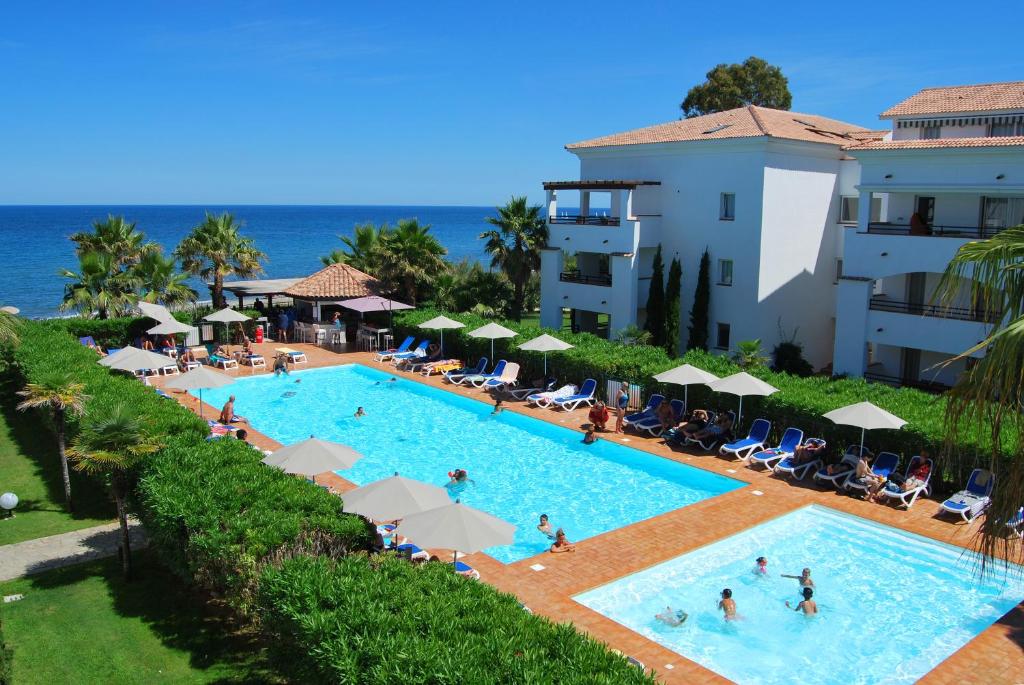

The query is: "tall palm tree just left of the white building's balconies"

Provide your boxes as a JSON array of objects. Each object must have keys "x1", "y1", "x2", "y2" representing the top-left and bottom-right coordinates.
[{"x1": 480, "y1": 196, "x2": 548, "y2": 320}]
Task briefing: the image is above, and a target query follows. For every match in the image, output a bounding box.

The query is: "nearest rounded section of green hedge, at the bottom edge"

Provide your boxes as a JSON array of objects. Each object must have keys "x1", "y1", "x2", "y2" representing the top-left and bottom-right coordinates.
[{"x1": 259, "y1": 555, "x2": 653, "y2": 685}]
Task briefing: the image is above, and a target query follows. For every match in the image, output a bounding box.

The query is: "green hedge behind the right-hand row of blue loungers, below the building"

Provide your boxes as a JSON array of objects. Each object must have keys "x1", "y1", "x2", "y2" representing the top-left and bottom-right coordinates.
[{"x1": 395, "y1": 309, "x2": 990, "y2": 482}]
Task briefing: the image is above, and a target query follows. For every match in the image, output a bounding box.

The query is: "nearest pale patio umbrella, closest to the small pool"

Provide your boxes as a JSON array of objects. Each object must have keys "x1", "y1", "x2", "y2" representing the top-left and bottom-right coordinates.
[{"x1": 395, "y1": 500, "x2": 515, "y2": 560}]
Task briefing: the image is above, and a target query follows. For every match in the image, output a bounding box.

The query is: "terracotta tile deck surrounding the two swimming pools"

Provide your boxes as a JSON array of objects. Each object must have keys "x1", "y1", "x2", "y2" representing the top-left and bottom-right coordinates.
[{"x1": 156, "y1": 343, "x2": 1024, "y2": 685}]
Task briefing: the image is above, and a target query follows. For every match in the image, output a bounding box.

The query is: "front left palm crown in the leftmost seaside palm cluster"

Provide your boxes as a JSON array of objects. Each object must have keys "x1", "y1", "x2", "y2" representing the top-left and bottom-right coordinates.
[{"x1": 57, "y1": 252, "x2": 138, "y2": 318}]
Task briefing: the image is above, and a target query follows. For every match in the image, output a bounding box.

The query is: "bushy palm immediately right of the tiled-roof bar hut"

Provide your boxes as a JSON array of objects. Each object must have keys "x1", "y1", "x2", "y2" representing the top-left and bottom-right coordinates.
[{"x1": 372, "y1": 219, "x2": 447, "y2": 305}]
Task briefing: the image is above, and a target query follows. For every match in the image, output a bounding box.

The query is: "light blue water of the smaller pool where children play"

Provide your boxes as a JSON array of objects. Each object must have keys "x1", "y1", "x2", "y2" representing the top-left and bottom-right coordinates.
[{"x1": 574, "y1": 505, "x2": 1024, "y2": 685}]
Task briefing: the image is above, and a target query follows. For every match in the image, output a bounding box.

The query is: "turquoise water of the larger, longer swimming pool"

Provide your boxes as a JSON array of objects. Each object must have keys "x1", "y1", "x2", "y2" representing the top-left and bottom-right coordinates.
[{"x1": 193, "y1": 365, "x2": 742, "y2": 562}]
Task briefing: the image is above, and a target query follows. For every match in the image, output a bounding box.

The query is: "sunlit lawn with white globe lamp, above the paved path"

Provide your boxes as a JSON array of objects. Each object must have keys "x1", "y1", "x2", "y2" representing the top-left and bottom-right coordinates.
[{"x1": 0, "y1": 405, "x2": 115, "y2": 545}]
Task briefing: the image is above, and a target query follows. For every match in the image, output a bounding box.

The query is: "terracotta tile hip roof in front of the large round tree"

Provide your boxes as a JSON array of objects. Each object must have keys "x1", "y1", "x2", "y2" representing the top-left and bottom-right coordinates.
[{"x1": 565, "y1": 104, "x2": 883, "y2": 149}]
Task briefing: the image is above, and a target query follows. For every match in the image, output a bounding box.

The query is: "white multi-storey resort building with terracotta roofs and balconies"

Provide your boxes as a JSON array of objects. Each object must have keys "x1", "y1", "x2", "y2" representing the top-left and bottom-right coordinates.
[{"x1": 541, "y1": 82, "x2": 1024, "y2": 384}]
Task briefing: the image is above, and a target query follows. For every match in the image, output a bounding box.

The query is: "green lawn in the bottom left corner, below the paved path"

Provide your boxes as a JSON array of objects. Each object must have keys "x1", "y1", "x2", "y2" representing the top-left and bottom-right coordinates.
[{"x1": 0, "y1": 552, "x2": 284, "y2": 685}]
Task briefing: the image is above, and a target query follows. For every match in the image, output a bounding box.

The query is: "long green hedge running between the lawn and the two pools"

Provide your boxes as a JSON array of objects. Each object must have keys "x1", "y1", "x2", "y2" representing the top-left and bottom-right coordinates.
[{"x1": 13, "y1": 319, "x2": 653, "y2": 683}]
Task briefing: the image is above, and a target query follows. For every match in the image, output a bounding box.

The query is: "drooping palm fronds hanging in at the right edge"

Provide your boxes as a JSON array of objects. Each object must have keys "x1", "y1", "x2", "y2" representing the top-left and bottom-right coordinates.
[{"x1": 934, "y1": 225, "x2": 1024, "y2": 558}]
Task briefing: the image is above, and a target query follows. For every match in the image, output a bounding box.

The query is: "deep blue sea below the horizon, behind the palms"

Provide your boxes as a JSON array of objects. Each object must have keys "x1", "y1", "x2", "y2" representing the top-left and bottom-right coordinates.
[{"x1": 0, "y1": 205, "x2": 495, "y2": 316}]
